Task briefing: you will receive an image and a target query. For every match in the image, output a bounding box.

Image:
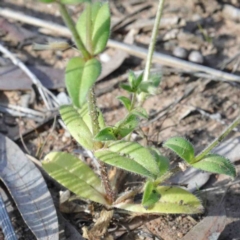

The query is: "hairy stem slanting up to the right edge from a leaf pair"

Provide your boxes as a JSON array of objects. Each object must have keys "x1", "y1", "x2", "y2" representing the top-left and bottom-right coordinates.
[{"x1": 195, "y1": 115, "x2": 240, "y2": 162}]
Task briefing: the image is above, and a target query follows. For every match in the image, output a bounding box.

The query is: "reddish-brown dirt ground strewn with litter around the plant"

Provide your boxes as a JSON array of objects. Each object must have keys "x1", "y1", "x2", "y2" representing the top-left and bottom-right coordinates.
[{"x1": 0, "y1": 0, "x2": 240, "y2": 240}]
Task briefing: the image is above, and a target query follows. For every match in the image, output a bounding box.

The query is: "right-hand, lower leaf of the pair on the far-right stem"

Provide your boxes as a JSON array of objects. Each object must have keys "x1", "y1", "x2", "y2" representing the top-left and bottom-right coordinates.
[{"x1": 191, "y1": 154, "x2": 236, "y2": 178}]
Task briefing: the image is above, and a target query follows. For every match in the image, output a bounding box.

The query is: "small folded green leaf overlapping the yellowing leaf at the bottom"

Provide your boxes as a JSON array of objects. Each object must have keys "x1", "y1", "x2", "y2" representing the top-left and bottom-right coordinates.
[{"x1": 142, "y1": 181, "x2": 161, "y2": 209}]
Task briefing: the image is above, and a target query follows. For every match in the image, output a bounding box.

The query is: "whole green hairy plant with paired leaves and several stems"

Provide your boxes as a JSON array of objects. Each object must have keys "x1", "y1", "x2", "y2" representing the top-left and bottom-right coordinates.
[{"x1": 39, "y1": 0, "x2": 236, "y2": 218}]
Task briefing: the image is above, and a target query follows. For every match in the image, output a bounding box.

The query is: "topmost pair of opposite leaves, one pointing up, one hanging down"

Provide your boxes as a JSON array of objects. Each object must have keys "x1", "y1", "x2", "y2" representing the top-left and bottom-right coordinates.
[{"x1": 65, "y1": 2, "x2": 110, "y2": 108}]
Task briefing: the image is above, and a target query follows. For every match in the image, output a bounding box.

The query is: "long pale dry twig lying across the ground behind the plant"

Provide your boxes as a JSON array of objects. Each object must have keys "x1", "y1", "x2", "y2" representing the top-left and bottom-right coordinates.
[{"x1": 0, "y1": 8, "x2": 240, "y2": 82}]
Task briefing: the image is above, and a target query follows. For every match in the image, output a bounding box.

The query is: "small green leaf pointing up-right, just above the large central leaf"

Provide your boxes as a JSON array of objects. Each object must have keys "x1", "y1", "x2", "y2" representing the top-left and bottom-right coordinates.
[{"x1": 115, "y1": 113, "x2": 140, "y2": 138}]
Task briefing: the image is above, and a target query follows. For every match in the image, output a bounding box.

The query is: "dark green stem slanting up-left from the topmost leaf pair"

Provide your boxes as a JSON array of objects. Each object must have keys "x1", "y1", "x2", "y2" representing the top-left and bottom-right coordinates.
[{"x1": 58, "y1": 2, "x2": 91, "y2": 59}]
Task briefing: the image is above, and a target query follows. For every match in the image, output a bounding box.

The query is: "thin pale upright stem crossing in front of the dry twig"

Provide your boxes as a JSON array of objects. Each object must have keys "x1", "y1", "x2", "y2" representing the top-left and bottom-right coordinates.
[{"x1": 140, "y1": 0, "x2": 165, "y2": 106}]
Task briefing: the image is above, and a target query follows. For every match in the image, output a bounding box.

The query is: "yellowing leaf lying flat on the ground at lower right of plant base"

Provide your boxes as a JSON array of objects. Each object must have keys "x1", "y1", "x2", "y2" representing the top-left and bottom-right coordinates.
[{"x1": 114, "y1": 186, "x2": 203, "y2": 214}]
